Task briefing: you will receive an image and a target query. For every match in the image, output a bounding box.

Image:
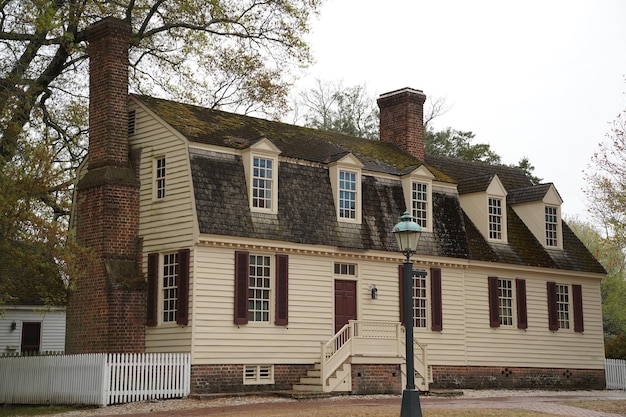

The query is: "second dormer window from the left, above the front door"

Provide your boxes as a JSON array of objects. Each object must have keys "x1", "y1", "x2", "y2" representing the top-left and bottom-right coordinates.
[{"x1": 328, "y1": 154, "x2": 363, "y2": 224}]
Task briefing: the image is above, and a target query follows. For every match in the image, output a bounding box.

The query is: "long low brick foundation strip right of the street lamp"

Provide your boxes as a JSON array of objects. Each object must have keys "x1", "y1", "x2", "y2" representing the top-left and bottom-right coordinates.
[{"x1": 430, "y1": 365, "x2": 606, "y2": 389}]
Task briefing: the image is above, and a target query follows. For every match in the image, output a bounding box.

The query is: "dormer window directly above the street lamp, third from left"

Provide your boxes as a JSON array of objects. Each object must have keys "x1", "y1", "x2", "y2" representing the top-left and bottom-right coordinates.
[{"x1": 402, "y1": 166, "x2": 434, "y2": 231}]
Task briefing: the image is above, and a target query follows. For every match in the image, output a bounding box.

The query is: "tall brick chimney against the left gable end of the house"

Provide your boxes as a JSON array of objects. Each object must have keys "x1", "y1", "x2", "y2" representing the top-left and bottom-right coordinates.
[{"x1": 65, "y1": 17, "x2": 146, "y2": 353}]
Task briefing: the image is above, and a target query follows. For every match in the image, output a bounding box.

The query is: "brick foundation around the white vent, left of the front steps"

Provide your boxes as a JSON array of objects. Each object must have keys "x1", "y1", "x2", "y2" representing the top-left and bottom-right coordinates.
[{"x1": 191, "y1": 364, "x2": 311, "y2": 394}]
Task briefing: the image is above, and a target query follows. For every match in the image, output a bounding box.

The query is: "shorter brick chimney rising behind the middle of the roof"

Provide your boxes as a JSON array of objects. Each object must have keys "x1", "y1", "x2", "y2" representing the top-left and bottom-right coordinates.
[{"x1": 377, "y1": 88, "x2": 426, "y2": 161}]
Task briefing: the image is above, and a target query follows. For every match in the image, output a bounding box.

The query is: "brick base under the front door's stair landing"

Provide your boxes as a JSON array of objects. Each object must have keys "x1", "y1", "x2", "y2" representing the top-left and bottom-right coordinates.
[{"x1": 352, "y1": 364, "x2": 402, "y2": 394}]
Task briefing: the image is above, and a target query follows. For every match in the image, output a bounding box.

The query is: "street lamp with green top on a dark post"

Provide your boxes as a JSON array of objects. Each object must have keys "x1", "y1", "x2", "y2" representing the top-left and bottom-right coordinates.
[{"x1": 391, "y1": 211, "x2": 422, "y2": 417}]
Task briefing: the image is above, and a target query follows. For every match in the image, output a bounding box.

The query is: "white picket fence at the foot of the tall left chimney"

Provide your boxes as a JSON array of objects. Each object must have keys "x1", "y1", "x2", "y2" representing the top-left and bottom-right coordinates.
[{"x1": 0, "y1": 353, "x2": 191, "y2": 406}]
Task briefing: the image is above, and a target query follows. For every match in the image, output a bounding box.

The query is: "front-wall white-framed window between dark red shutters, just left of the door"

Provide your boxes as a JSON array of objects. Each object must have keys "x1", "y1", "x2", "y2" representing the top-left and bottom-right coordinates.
[{"x1": 248, "y1": 255, "x2": 271, "y2": 322}]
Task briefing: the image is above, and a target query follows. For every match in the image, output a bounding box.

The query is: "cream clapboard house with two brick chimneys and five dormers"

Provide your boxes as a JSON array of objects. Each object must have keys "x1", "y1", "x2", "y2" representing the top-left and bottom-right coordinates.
[{"x1": 66, "y1": 18, "x2": 605, "y2": 393}]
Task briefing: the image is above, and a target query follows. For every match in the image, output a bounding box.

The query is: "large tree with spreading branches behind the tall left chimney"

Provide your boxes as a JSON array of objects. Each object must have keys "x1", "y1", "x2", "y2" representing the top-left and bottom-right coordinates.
[{"x1": 0, "y1": 0, "x2": 322, "y2": 302}]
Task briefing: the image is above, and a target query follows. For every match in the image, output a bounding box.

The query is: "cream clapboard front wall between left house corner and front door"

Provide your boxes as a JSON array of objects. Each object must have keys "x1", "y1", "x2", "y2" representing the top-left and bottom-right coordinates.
[{"x1": 193, "y1": 246, "x2": 334, "y2": 364}]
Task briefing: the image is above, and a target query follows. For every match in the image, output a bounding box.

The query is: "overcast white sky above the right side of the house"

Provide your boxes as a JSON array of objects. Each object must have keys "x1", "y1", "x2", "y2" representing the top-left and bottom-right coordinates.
[{"x1": 299, "y1": 0, "x2": 626, "y2": 219}]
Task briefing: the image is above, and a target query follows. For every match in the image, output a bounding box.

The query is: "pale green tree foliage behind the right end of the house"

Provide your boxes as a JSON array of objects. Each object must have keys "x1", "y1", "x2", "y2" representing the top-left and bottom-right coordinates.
[{"x1": 567, "y1": 219, "x2": 626, "y2": 338}]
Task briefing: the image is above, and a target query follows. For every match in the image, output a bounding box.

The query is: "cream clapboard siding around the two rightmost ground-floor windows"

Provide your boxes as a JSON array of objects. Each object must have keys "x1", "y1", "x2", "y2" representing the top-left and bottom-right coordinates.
[{"x1": 460, "y1": 270, "x2": 604, "y2": 369}]
